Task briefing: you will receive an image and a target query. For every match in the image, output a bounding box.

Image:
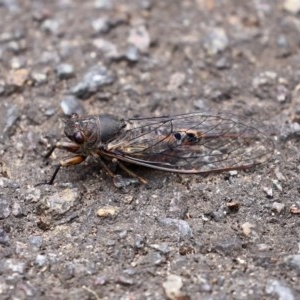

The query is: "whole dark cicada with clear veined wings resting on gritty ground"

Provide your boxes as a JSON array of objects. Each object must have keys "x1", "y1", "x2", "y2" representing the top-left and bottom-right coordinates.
[{"x1": 47, "y1": 113, "x2": 274, "y2": 184}]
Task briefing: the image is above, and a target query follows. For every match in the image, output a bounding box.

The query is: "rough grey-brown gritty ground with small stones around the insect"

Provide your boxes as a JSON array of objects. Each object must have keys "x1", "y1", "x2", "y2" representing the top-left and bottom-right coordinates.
[{"x1": 0, "y1": 0, "x2": 300, "y2": 300}]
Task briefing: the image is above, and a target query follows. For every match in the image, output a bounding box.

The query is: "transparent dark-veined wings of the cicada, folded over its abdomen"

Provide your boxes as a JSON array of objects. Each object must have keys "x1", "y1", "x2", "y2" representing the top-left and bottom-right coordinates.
[{"x1": 108, "y1": 113, "x2": 274, "y2": 173}]
